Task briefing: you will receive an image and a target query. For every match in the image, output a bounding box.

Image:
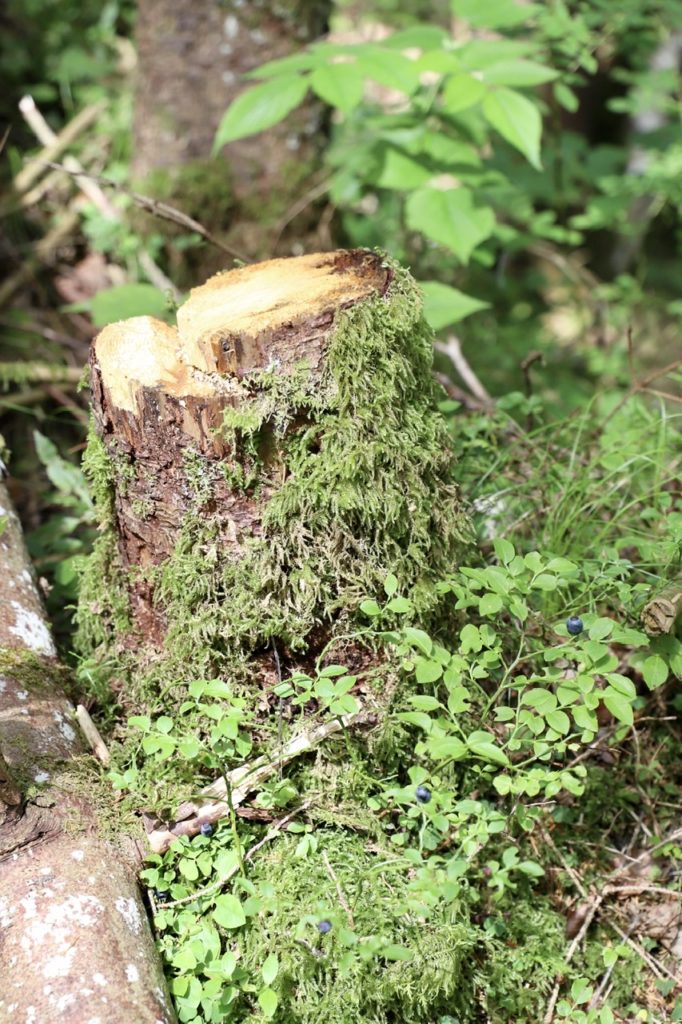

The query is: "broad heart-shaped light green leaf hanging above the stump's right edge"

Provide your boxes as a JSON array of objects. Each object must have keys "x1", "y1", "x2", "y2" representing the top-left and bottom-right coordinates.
[{"x1": 406, "y1": 187, "x2": 495, "y2": 263}]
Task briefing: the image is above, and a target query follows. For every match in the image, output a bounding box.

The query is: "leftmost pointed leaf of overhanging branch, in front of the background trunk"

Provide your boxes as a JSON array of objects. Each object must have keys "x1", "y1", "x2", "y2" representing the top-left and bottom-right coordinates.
[{"x1": 213, "y1": 75, "x2": 308, "y2": 153}]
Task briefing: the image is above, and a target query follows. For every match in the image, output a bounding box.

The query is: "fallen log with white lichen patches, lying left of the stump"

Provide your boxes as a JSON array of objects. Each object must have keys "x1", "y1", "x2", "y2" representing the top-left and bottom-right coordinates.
[{"x1": 0, "y1": 481, "x2": 175, "y2": 1024}]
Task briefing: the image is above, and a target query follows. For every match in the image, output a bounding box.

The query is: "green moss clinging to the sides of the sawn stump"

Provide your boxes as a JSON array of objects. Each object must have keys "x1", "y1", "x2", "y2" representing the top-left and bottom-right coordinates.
[{"x1": 74, "y1": 256, "x2": 469, "y2": 704}]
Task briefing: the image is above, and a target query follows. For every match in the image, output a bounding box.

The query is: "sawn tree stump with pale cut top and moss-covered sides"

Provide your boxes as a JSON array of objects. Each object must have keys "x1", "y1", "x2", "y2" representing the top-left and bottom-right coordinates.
[{"x1": 80, "y1": 250, "x2": 467, "y2": 704}]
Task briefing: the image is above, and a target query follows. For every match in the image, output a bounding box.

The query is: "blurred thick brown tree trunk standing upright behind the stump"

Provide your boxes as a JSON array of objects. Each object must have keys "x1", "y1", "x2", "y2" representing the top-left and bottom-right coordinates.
[{"x1": 133, "y1": 0, "x2": 331, "y2": 218}]
